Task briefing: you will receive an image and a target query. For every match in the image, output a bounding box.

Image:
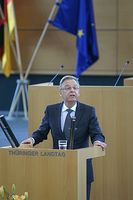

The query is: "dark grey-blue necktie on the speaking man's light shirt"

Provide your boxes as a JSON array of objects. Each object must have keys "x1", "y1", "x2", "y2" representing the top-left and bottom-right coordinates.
[{"x1": 63, "y1": 109, "x2": 73, "y2": 140}]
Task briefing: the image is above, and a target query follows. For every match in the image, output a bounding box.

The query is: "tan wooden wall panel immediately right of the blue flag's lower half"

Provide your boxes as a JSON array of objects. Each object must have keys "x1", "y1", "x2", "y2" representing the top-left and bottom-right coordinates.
[{"x1": 88, "y1": 31, "x2": 117, "y2": 75}]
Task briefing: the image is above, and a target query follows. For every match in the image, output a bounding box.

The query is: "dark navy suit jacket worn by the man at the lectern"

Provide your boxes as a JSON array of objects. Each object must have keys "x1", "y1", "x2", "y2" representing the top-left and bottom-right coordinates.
[{"x1": 32, "y1": 102, "x2": 104, "y2": 182}]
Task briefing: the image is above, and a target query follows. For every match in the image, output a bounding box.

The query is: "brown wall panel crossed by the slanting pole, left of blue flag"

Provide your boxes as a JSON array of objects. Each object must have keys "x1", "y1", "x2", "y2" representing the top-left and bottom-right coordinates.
[{"x1": 20, "y1": 30, "x2": 75, "y2": 74}]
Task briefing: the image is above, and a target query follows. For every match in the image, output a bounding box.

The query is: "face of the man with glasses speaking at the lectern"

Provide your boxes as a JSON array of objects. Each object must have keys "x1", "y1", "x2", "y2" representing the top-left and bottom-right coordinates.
[{"x1": 60, "y1": 79, "x2": 79, "y2": 105}]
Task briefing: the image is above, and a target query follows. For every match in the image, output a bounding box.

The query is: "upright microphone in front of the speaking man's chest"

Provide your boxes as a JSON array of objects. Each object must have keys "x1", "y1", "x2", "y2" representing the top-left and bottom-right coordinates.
[{"x1": 70, "y1": 116, "x2": 76, "y2": 149}]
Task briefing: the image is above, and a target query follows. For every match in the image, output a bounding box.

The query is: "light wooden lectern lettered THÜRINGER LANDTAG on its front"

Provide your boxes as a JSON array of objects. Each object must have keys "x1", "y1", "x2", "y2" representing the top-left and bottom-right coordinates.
[{"x1": 0, "y1": 147, "x2": 105, "y2": 200}]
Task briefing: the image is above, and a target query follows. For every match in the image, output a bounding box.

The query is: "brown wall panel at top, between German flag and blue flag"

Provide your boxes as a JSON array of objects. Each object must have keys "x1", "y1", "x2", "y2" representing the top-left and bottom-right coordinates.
[{"x1": 14, "y1": 0, "x2": 55, "y2": 30}]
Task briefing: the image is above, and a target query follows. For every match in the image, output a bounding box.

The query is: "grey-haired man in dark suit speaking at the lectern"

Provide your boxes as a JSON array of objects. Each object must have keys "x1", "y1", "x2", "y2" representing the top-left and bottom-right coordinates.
[{"x1": 22, "y1": 76, "x2": 106, "y2": 200}]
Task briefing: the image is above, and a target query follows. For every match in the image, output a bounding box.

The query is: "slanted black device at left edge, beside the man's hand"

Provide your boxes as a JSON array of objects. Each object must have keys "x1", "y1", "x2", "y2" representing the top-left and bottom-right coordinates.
[{"x1": 0, "y1": 115, "x2": 19, "y2": 148}]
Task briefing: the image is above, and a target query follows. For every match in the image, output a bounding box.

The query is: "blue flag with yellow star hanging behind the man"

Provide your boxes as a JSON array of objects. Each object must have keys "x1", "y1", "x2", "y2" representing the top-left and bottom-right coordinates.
[{"x1": 50, "y1": 0, "x2": 99, "y2": 77}]
